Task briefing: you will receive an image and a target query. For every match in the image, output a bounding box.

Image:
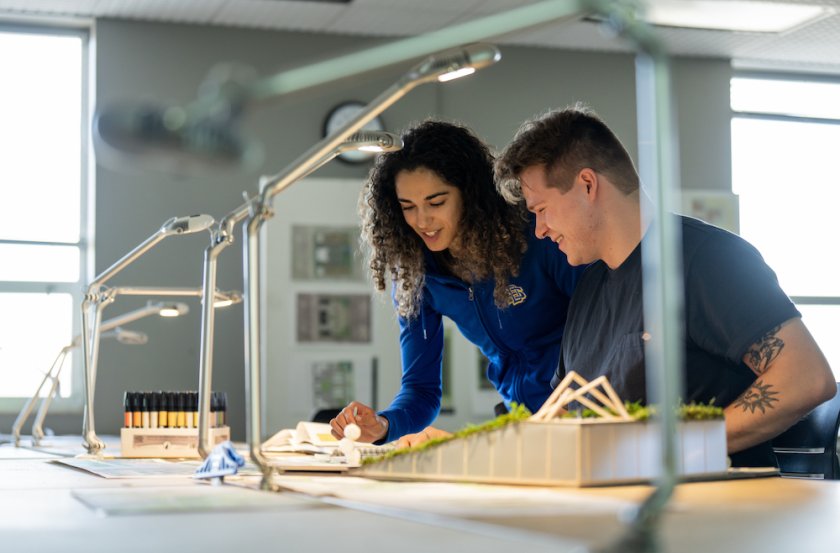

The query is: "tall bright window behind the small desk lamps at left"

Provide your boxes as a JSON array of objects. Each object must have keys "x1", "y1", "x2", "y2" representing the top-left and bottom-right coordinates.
[{"x1": 0, "y1": 28, "x2": 88, "y2": 412}]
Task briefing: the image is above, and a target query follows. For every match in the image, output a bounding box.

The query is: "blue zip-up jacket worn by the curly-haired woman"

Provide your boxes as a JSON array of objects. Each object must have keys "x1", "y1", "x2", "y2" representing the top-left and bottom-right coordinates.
[{"x1": 379, "y1": 217, "x2": 585, "y2": 441}]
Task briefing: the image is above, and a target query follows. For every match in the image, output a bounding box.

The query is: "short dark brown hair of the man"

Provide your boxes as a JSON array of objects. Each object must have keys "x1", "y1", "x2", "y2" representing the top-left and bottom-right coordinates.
[{"x1": 495, "y1": 103, "x2": 639, "y2": 203}]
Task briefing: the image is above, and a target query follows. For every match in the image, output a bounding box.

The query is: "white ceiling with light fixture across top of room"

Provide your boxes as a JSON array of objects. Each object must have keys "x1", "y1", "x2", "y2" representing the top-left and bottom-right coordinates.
[{"x1": 0, "y1": 0, "x2": 840, "y2": 73}]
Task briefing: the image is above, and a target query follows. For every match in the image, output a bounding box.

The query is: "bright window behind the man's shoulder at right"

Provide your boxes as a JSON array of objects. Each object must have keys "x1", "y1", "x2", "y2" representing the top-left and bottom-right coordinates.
[{"x1": 731, "y1": 75, "x2": 840, "y2": 380}]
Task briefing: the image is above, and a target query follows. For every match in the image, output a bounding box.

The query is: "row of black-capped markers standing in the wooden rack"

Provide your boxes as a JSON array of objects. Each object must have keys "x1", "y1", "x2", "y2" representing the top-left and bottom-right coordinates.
[{"x1": 123, "y1": 391, "x2": 227, "y2": 428}]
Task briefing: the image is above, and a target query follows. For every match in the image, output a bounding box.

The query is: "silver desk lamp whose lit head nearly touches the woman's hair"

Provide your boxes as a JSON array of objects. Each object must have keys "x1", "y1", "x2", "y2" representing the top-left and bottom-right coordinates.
[{"x1": 198, "y1": 131, "x2": 402, "y2": 458}]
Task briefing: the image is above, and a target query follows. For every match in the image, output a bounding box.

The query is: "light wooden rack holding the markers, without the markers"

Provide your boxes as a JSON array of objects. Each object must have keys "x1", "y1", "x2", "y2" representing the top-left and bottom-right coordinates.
[{"x1": 120, "y1": 426, "x2": 230, "y2": 459}]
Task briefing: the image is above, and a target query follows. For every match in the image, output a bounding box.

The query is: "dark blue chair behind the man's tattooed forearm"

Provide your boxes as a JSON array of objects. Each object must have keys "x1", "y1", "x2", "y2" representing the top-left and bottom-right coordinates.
[{"x1": 772, "y1": 382, "x2": 840, "y2": 480}]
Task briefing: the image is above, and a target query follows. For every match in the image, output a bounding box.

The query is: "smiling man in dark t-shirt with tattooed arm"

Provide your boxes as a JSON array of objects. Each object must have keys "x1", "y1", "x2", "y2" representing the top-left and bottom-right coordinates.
[{"x1": 496, "y1": 106, "x2": 836, "y2": 466}]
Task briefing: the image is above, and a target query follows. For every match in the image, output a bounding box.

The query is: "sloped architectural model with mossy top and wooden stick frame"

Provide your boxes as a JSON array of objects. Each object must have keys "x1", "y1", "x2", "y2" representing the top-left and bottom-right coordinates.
[{"x1": 354, "y1": 372, "x2": 727, "y2": 486}]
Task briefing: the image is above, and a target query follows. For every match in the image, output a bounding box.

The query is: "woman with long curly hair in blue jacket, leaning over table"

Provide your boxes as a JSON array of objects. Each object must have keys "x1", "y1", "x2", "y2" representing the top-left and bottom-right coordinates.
[{"x1": 330, "y1": 121, "x2": 582, "y2": 442}]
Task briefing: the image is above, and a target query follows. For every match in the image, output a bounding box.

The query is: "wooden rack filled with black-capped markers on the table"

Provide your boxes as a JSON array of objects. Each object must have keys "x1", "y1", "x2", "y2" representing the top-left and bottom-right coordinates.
[{"x1": 120, "y1": 391, "x2": 230, "y2": 458}]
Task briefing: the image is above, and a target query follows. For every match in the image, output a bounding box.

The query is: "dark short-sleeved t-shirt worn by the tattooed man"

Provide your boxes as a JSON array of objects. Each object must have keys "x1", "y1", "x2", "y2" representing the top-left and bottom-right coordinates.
[{"x1": 552, "y1": 217, "x2": 800, "y2": 466}]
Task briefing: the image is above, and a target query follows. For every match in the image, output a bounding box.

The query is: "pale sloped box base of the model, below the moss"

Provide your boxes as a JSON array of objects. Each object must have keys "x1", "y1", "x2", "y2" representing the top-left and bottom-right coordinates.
[{"x1": 353, "y1": 418, "x2": 727, "y2": 486}]
